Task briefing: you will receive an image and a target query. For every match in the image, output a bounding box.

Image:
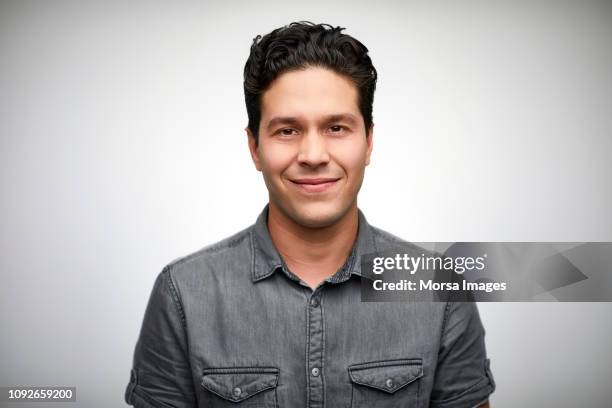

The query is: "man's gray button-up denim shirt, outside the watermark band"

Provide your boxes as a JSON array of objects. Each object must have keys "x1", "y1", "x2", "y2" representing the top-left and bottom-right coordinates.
[{"x1": 125, "y1": 206, "x2": 495, "y2": 408}]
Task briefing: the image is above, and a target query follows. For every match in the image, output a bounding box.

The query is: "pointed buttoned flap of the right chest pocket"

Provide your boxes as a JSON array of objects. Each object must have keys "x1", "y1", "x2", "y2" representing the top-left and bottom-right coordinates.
[{"x1": 348, "y1": 358, "x2": 423, "y2": 394}]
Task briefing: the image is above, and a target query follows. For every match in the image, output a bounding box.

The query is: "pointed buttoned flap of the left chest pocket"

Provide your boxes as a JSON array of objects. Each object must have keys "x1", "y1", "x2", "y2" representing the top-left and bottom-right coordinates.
[{"x1": 202, "y1": 367, "x2": 278, "y2": 402}]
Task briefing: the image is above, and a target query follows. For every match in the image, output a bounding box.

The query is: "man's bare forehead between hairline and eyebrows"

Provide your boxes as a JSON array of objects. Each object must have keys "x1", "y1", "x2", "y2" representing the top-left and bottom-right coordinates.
[{"x1": 261, "y1": 67, "x2": 360, "y2": 123}]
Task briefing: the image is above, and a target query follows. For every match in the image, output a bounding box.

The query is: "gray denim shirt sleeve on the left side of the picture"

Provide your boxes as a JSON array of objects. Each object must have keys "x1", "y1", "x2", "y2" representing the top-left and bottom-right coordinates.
[{"x1": 125, "y1": 266, "x2": 197, "y2": 408}]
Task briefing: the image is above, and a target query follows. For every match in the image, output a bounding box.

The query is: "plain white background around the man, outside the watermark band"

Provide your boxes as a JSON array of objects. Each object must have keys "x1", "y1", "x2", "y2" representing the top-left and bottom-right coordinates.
[{"x1": 0, "y1": 0, "x2": 612, "y2": 408}]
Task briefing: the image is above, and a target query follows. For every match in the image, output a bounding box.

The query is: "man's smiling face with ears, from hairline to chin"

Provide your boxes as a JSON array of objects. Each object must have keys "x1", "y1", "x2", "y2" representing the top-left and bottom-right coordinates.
[{"x1": 247, "y1": 67, "x2": 373, "y2": 228}]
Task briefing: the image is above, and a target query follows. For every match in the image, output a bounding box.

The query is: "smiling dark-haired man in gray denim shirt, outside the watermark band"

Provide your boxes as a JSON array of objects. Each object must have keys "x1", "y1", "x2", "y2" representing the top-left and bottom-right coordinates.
[{"x1": 125, "y1": 22, "x2": 495, "y2": 408}]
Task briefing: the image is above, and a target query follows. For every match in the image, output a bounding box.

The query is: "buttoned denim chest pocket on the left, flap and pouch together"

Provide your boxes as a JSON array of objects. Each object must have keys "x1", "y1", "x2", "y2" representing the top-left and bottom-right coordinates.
[{"x1": 201, "y1": 367, "x2": 278, "y2": 408}]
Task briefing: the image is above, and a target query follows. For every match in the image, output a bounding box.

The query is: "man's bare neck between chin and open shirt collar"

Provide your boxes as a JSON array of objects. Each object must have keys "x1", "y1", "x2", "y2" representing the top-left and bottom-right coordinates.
[{"x1": 268, "y1": 202, "x2": 359, "y2": 287}]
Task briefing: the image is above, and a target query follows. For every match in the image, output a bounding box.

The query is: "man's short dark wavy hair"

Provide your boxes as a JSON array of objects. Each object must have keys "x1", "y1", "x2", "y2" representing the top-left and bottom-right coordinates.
[{"x1": 244, "y1": 21, "x2": 377, "y2": 143}]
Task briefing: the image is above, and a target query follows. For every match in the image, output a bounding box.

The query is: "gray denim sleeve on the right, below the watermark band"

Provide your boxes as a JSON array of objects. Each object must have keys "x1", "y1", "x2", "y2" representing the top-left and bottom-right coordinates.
[{"x1": 430, "y1": 302, "x2": 495, "y2": 408}]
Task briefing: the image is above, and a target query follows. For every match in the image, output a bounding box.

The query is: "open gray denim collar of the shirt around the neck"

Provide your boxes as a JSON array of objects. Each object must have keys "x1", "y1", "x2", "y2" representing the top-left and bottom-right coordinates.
[{"x1": 250, "y1": 204, "x2": 378, "y2": 283}]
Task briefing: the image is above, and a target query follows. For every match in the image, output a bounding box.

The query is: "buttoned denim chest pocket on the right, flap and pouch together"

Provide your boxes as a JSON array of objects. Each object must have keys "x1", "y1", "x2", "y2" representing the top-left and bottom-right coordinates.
[{"x1": 348, "y1": 359, "x2": 423, "y2": 408}]
